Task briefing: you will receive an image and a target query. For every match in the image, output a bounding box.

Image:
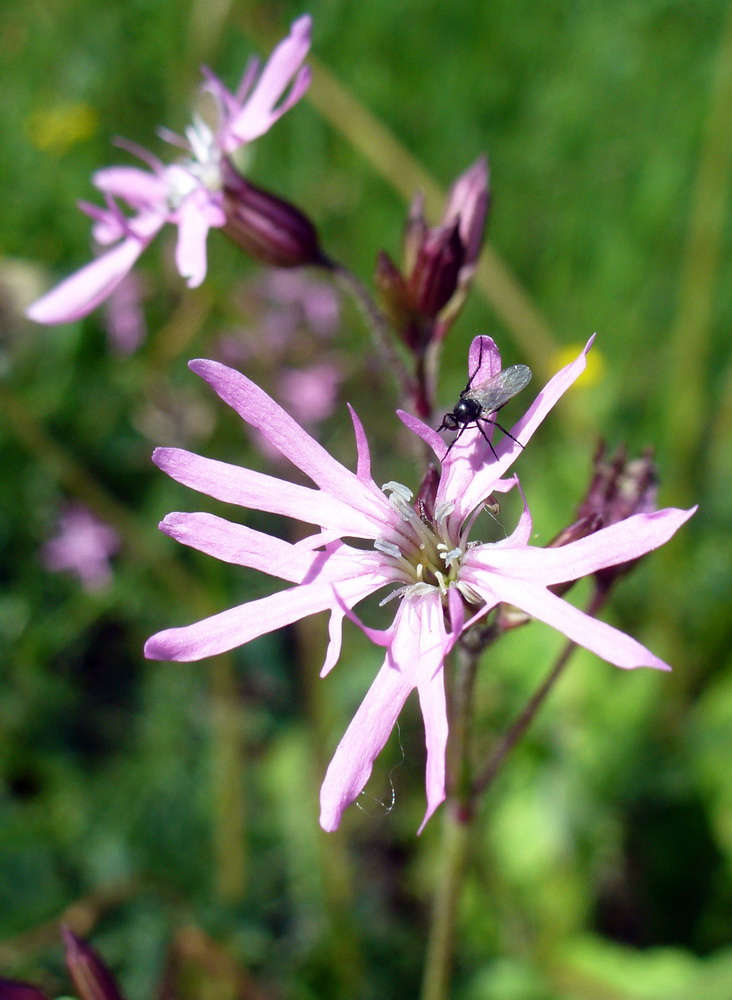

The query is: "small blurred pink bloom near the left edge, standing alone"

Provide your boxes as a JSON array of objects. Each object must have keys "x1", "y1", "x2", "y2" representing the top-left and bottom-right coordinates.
[{"x1": 41, "y1": 503, "x2": 121, "y2": 591}]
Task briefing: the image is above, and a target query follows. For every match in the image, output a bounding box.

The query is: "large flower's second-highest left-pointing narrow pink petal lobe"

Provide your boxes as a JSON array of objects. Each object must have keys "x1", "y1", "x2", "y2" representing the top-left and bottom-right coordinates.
[{"x1": 153, "y1": 448, "x2": 378, "y2": 538}]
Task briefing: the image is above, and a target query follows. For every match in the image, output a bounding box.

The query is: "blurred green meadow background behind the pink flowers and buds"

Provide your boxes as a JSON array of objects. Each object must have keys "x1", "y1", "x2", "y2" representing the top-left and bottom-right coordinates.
[{"x1": 0, "y1": 0, "x2": 732, "y2": 1000}]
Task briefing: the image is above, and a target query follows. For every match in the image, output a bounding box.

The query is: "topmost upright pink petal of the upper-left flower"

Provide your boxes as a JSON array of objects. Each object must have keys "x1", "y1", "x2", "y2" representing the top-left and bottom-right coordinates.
[{"x1": 227, "y1": 15, "x2": 312, "y2": 146}]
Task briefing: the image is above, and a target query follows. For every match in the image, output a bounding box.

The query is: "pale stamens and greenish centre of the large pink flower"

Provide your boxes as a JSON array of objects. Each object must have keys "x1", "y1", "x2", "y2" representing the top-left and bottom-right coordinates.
[{"x1": 374, "y1": 482, "x2": 463, "y2": 600}]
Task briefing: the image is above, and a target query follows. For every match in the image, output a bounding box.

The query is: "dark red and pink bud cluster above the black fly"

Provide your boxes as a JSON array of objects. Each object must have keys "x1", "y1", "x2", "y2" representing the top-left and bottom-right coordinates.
[{"x1": 375, "y1": 157, "x2": 489, "y2": 355}]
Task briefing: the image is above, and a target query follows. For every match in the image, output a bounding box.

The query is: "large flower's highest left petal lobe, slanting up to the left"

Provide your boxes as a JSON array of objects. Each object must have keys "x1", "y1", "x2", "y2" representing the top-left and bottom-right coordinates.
[{"x1": 189, "y1": 360, "x2": 394, "y2": 525}]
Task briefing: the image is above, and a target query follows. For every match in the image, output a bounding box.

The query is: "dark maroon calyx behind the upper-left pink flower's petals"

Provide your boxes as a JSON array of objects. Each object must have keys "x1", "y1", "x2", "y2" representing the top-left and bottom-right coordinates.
[{"x1": 221, "y1": 159, "x2": 332, "y2": 268}]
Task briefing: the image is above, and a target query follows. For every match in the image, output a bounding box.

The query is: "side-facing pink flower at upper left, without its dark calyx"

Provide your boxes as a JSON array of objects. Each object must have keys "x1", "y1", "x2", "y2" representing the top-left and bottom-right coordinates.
[{"x1": 27, "y1": 15, "x2": 311, "y2": 324}]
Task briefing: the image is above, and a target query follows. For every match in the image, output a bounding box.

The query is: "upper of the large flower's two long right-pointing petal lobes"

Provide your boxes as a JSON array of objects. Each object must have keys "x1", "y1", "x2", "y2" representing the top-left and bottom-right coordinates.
[{"x1": 464, "y1": 507, "x2": 696, "y2": 586}]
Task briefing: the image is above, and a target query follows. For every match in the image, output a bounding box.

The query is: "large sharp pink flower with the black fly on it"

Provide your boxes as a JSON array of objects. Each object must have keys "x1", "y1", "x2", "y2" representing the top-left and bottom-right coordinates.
[{"x1": 145, "y1": 337, "x2": 693, "y2": 830}]
